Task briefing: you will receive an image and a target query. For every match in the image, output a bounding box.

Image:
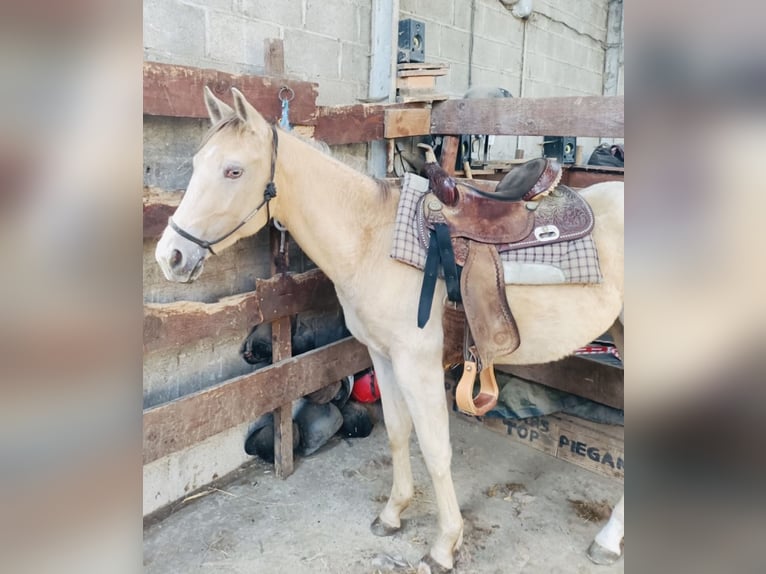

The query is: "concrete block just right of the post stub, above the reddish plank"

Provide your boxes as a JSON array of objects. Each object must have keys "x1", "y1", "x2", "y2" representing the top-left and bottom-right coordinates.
[{"x1": 285, "y1": 29, "x2": 340, "y2": 81}]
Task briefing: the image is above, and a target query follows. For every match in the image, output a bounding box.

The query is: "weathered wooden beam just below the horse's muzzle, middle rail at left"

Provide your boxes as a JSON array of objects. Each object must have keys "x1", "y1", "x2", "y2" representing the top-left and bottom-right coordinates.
[{"x1": 144, "y1": 269, "x2": 339, "y2": 353}]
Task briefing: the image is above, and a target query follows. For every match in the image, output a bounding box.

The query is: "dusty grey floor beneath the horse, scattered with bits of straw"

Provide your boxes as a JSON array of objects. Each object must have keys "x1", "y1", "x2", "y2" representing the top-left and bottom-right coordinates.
[{"x1": 144, "y1": 418, "x2": 624, "y2": 574}]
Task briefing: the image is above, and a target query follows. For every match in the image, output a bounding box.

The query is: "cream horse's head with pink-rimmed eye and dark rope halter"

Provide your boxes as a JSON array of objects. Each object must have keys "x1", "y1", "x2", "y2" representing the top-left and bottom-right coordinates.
[{"x1": 155, "y1": 87, "x2": 277, "y2": 282}]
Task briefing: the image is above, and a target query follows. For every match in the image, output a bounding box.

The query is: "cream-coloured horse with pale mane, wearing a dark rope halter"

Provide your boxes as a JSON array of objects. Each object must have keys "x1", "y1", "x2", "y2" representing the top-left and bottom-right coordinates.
[{"x1": 155, "y1": 88, "x2": 624, "y2": 572}]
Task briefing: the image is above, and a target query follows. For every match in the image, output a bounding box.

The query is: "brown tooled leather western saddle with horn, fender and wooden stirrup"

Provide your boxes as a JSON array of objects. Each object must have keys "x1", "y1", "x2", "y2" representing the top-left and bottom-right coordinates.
[{"x1": 417, "y1": 158, "x2": 594, "y2": 416}]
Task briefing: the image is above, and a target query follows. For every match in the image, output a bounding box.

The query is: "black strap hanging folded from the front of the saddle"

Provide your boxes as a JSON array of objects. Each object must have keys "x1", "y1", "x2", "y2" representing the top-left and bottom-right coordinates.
[{"x1": 418, "y1": 223, "x2": 462, "y2": 329}]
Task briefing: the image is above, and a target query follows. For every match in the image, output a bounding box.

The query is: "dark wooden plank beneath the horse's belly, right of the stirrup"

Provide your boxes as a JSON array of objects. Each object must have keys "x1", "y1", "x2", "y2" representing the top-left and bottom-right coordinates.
[{"x1": 495, "y1": 357, "x2": 625, "y2": 409}]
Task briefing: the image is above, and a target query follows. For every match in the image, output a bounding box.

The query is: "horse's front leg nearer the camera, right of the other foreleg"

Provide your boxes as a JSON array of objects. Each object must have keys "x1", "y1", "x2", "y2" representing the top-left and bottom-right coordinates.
[{"x1": 394, "y1": 354, "x2": 463, "y2": 572}]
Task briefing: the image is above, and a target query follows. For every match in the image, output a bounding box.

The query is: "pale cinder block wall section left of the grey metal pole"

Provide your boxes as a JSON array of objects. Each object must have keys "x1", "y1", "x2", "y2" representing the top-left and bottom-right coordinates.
[{"x1": 144, "y1": 0, "x2": 371, "y2": 105}]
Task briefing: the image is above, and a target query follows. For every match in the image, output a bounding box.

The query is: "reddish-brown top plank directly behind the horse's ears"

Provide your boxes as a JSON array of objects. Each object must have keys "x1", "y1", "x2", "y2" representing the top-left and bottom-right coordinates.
[{"x1": 144, "y1": 62, "x2": 318, "y2": 125}]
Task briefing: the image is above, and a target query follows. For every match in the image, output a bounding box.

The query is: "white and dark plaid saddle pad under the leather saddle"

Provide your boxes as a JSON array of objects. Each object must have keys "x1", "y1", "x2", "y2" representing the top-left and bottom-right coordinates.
[{"x1": 391, "y1": 173, "x2": 602, "y2": 285}]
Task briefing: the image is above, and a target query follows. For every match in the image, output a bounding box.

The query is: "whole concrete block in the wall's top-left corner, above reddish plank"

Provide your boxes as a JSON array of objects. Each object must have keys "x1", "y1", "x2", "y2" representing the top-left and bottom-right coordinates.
[{"x1": 144, "y1": 0, "x2": 206, "y2": 58}]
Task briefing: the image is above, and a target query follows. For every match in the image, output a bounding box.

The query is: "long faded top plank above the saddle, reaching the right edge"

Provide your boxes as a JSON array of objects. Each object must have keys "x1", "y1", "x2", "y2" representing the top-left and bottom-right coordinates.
[{"x1": 431, "y1": 96, "x2": 625, "y2": 138}]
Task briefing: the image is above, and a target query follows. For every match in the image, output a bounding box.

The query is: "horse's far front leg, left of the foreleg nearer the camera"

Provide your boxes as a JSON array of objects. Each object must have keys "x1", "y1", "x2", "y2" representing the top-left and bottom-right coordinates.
[{"x1": 370, "y1": 351, "x2": 414, "y2": 536}]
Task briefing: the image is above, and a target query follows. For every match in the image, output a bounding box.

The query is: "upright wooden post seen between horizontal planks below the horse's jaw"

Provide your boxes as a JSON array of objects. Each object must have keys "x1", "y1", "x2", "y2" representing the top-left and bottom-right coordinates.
[{"x1": 270, "y1": 227, "x2": 294, "y2": 478}]
